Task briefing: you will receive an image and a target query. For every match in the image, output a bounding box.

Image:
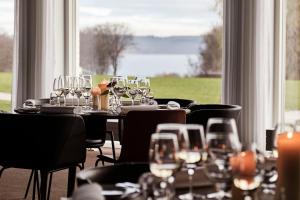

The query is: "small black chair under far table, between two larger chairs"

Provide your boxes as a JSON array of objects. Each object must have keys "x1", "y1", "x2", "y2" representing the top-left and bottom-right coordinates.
[{"x1": 82, "y1": 114, "x2": 116, "y2": 167}]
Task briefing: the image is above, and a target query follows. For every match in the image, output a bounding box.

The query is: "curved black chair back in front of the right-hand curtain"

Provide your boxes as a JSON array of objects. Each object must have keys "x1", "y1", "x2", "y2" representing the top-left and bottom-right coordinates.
[{"x1": 187, "y1": 104, "x2": 242, "y2": 129}]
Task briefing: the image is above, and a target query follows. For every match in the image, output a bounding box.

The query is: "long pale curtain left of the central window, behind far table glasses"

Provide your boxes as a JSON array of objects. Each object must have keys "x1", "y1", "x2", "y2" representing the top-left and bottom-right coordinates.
[{"x1": 12, "y1": 0, "x2": 77, "y2": 108}]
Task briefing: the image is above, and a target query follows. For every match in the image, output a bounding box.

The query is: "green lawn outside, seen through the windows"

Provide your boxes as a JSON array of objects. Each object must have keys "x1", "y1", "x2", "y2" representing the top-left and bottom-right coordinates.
[{"x1": 0, "y1": 73, "x2": 300, "y2": 110}]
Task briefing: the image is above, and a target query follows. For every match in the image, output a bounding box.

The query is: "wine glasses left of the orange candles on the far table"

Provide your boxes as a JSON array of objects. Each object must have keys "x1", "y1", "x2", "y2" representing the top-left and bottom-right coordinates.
[{"x1": 50, "y1": 75, "x2": 92, "y2": 110}]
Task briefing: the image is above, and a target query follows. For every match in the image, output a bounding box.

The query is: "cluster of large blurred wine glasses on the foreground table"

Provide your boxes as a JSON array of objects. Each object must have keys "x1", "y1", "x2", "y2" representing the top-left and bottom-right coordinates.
[{"x1": 149, "y1": 118, "x2": 263, "y2": 200}]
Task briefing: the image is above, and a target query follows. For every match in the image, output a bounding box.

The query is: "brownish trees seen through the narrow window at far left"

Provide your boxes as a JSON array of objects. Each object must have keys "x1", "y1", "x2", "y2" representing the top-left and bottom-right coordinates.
[{"x1": 0, "y1": 33, "x2": 13, "y2": 71}]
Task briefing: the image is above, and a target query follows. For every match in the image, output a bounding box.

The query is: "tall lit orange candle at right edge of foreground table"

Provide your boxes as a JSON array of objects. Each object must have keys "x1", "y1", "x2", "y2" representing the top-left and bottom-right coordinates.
[{"x1": 276, "y1": 132, "x2": 300, "y2": 200}]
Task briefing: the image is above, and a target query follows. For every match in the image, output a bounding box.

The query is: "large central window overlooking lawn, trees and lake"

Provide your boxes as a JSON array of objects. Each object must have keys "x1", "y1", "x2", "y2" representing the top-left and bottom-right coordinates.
[{"x1": 79, "y1": 0, "x2": 222, "y2": 103}]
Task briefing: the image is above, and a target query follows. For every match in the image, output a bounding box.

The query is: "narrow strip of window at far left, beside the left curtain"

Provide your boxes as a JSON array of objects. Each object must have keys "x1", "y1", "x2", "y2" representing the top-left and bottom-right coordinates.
[{"x1": 0, "y1": 0, "x2": 14, "y2": 111}]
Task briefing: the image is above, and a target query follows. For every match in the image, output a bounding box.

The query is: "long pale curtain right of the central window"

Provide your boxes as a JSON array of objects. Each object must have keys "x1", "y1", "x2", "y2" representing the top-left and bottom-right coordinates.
[{"x1": 223, "y1": 0, "x2": 274, "y2": 150}]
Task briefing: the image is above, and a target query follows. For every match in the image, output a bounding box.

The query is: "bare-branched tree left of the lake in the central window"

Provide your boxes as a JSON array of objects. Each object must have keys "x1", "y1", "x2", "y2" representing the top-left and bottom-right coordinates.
[{"x1": 80, "y1": 24, "x2": 133, "y2": 75}]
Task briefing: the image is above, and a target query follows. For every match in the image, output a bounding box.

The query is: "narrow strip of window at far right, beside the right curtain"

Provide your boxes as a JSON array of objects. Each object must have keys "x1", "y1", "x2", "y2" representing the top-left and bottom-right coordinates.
[{"x1": 285, "y1": 0, "x2": 300, "y2": 123}]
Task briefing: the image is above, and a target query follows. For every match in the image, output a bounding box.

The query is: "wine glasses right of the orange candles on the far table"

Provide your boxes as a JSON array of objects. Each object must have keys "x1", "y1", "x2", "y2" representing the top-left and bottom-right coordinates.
[{"x1": 110, "y1": 76, "x2": 151, "y2": 110}]
